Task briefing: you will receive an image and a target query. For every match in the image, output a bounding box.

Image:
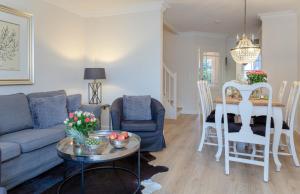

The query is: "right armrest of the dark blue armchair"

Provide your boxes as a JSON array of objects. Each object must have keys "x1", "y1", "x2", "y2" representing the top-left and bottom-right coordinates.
[{"x1": 151, "y1": 98, "x2": 166, "y2": 130}]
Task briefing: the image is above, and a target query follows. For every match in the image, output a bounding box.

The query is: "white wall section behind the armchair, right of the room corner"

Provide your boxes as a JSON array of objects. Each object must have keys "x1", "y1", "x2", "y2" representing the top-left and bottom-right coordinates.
[{"x1": 85, "y1": 11, "x2": 162, "y2": 127}]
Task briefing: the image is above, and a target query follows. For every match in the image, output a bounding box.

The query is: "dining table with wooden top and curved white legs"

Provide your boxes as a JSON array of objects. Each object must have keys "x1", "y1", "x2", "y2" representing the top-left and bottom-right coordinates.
[{"x1": 214, "y1": 97, "x2": 284, "y2": 171}]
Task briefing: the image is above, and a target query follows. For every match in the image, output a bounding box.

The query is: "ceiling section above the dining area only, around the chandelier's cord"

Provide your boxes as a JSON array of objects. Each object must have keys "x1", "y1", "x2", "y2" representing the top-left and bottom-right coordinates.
[{"x1": 165, "y1": 0, "x2": 300, "y2": 33}]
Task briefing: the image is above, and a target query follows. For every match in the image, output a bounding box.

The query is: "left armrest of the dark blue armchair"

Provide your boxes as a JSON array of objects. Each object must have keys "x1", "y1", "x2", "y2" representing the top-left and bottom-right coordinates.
[{"x1": 110, "y1": 98, "x2": 123, "y2": 130}]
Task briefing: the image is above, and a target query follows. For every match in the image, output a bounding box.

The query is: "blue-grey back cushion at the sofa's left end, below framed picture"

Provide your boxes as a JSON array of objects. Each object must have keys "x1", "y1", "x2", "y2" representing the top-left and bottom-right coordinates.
[{"x1": 0, "y1": 93, "x2": 33, "y2": 135}]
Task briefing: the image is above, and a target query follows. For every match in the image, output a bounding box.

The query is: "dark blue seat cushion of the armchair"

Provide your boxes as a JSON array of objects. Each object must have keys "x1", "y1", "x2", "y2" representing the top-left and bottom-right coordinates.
[{"x1": 121, "y1": 120, "x2": 156, "y2": 132}]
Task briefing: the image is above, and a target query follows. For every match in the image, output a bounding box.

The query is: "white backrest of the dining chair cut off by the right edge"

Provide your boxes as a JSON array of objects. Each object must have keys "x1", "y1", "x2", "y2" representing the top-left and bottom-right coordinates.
[{"x1": 284, "y1": 81, "x2": 300, "y2": 130}]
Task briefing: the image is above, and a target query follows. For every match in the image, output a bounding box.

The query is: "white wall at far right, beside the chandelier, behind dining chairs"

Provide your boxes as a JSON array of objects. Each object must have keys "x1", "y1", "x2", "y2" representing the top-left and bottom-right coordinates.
[{"x1": 261, "y1": 13, "x2": 299, "y2": 97}]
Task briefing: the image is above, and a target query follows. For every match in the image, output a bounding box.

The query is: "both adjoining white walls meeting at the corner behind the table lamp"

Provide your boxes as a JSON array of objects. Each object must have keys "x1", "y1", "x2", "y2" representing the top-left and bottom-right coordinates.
[{"x1": 0, "y1": 0, "x2": 162, "y2": 126}]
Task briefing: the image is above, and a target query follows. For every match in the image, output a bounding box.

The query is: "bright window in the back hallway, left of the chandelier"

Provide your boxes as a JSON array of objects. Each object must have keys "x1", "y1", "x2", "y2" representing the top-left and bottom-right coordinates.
[{"x1": 199, "y1": 52, "x2": 220, "y2": 85}]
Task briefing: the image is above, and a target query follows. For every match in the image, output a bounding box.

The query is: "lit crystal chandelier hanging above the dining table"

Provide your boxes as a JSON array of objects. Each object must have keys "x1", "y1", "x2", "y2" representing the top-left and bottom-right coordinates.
[{"x1": 230, "y1": 0, "x2": 260, "y2": 64}]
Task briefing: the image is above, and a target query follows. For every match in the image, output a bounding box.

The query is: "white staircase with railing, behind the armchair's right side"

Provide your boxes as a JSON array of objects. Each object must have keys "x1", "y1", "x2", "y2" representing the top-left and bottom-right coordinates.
[{"x1": 163, "y1": 65, "x2": 180, "y2": 119}]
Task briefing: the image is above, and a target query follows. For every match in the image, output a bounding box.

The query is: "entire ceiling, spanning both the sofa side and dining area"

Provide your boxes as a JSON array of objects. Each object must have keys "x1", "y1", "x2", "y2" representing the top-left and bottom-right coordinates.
[{"x1": 44, "y1": 0, "x2": 300, "y2": 33}]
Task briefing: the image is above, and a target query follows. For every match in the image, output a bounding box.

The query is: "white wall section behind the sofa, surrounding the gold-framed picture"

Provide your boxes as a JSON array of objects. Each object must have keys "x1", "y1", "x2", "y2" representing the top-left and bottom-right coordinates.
[{"x1": 0, "y1": 0, "x2": 85, "y2": 94}]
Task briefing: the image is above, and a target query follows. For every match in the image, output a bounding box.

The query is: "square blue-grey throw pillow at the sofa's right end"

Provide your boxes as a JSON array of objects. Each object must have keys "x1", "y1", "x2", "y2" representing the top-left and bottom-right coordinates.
[{"x1": 30, "y1": 95, "x2": 68, "y2": 129}]
